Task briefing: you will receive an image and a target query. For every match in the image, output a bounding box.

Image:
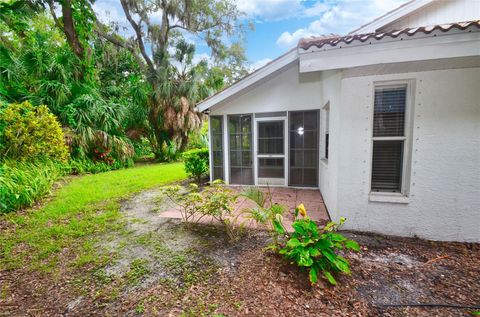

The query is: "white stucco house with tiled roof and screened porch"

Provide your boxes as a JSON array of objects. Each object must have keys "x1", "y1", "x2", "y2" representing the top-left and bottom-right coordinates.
[{"x1": 198, "y1": 0, "x2": 480, "y2": 242}]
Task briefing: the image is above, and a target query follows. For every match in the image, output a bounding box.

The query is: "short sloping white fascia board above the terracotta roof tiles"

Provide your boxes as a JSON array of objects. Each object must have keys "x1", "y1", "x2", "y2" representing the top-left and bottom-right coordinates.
[{"x1": 349, "y1": 0, "x2": 435, "y2": 34}]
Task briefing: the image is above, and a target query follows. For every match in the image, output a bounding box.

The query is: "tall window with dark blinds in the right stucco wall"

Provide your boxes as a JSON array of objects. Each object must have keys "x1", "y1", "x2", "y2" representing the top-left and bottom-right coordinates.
[{"x1": 371, "y1": 84, "x2": 408, "y2": 193}]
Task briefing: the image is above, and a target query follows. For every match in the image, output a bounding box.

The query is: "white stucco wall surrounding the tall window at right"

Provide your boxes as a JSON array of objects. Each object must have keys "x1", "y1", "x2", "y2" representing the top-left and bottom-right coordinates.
[{"x1": 331, "y1": 68, "x2": 480, "y2": 242}]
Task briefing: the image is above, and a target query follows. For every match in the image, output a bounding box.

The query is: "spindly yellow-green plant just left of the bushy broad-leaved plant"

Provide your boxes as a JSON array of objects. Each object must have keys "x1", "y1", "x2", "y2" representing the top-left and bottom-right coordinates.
[{"x1": 241, "y1": 187, "x2": 286, "y2": 248}]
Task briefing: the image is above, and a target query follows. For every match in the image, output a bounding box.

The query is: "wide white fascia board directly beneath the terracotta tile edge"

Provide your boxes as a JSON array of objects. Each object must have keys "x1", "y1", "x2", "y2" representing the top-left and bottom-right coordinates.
[{"x1": 299, "y1": 32, "x2": 480, "y2": 73}]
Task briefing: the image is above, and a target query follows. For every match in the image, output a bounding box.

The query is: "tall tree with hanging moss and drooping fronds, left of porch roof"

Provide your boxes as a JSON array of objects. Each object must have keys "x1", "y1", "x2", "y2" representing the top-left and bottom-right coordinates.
[{"x1": 98, "y1": 0, "x2": 245, "y2": 159}]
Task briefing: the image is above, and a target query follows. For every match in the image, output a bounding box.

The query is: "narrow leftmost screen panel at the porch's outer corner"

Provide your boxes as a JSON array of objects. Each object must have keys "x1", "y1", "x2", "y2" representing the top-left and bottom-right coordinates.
[{"x1": 210, "y1": 116, "x2": 224, "y2": 180}]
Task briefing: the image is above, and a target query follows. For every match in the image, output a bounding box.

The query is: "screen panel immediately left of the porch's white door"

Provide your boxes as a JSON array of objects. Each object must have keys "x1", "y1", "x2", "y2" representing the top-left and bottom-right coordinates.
[{"x1": 228, "y1": 115, "x2": 254, "y2": 185}]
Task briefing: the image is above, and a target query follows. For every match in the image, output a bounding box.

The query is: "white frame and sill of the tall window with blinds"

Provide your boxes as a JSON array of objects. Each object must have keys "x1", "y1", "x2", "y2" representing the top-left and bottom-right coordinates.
[{"x1": 369, "y1": 79, "x2": 415, "y2": 203}]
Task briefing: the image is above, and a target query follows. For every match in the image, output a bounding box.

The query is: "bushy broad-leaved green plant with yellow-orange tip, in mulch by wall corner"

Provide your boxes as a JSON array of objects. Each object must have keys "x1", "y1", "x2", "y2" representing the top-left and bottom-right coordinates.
[{"x1": 277, "y1": 204, "x2": 360, "y2": 285}]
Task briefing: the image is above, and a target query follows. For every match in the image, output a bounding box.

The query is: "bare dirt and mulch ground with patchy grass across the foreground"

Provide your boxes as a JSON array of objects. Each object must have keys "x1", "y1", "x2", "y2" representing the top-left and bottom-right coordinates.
[{"x1": 0, "y1": 190, "x2": 480, "y2": 317}]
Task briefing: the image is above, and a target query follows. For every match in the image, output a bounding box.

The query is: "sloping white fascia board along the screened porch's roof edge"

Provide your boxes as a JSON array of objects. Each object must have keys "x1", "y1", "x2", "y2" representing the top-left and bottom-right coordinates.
[{"x1": 197, "y1": 48, "x2": 298, "y2": 112}]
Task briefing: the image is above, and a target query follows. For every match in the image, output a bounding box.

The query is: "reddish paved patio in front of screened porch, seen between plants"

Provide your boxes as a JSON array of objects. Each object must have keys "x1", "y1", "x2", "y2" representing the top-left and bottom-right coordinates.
[{"x1": 160, "y1": 186, "x2": 330, "y2": 229}]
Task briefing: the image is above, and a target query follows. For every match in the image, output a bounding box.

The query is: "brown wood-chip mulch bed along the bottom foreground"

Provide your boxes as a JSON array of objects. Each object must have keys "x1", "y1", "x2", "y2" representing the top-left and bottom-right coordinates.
[{"x1": 0, "y1": 228, "x2": 480, "y2": 316}]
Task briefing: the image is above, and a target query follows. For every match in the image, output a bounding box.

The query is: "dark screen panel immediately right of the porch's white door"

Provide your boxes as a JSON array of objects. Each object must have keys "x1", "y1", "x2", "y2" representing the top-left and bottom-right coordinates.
[{"x1": 288, "y1": 110, "x2": 319, "y2": 187}]
